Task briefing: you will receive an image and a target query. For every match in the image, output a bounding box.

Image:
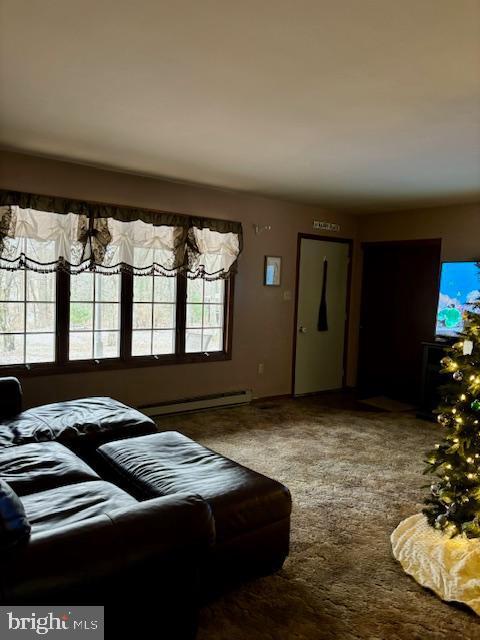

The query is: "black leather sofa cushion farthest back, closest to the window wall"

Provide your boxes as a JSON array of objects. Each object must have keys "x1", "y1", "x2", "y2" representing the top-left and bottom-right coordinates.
[{"x1": 0, "y1": 397, "x2": 156, "y2": 448}]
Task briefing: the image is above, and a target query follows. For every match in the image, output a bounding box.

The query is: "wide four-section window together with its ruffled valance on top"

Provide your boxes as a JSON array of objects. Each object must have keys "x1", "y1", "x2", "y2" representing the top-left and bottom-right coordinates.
[{"x1": 0, "y1": 195, "x2": 239, "y2": 375}]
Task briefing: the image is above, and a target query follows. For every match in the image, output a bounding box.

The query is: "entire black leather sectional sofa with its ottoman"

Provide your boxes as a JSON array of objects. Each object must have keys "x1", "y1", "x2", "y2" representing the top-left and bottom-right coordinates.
[{"x1": 0, "y1": 378, "x2": 291, "y2": 640}]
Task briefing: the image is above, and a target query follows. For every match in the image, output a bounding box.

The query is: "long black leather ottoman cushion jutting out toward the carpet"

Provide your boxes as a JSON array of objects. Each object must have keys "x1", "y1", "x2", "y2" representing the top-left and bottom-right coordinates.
[{"x1": 98, "y1": 431, "x2": 291, "y2": 541}]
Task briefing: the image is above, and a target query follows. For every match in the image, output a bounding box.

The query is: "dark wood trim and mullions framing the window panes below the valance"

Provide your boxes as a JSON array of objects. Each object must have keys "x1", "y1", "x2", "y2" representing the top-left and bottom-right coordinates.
[{"x1": 0, "y1": 271, "x2": 235, "y2": 377}]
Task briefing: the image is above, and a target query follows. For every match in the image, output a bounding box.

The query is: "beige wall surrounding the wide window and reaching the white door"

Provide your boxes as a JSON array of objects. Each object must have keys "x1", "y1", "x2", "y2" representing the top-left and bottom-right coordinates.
[{"x1": 0, "y1": 152, "x2": 358, "y2": 405}]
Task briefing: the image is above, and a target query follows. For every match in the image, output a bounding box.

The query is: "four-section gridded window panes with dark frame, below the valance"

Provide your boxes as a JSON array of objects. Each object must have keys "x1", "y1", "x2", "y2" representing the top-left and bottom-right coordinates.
[{"x1": 0, "y1": 269, "x2": 233, "y2": 371}]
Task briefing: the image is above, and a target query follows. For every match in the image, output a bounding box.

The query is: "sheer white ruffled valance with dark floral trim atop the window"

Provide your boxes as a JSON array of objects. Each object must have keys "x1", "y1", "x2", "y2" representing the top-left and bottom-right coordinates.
[{"x1": 0, "y1": 191, "x2": 242, "y2": 280}]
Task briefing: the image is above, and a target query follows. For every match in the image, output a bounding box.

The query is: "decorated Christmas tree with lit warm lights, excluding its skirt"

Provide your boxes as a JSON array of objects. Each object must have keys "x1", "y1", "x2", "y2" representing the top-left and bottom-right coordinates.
[{"x1": 423, "y1": 278, "x2": 480, "y2": 538}]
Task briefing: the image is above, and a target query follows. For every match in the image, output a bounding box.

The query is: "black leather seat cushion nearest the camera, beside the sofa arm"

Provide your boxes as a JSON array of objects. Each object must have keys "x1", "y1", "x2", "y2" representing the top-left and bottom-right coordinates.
[{"x1": 22, "y1": 480, "x2": 138, "y2": 534}]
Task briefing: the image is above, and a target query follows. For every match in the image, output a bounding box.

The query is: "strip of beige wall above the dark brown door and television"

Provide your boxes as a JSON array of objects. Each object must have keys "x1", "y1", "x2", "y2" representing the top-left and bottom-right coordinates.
[{"x1": 359, "y1": 203, "x2": 480, "y2": 260}]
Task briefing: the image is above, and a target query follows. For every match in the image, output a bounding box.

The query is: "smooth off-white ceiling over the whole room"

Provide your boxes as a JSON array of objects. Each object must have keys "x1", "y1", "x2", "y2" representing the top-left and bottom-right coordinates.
[{"x1": 0, "y1": 0, "x2": 480, "y2": 212}]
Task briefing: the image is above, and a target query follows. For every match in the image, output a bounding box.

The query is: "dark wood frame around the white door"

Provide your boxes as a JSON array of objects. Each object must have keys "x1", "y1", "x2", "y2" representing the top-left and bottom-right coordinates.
[{"x1": 292, "y1": 233, "x2": 353, "y2": 396}]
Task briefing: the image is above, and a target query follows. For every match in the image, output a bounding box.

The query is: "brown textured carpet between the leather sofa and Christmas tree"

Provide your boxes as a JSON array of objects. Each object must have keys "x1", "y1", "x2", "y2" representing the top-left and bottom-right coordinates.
[{"x1": 158, "y1": 398, "x2": 480, "y2": 640}]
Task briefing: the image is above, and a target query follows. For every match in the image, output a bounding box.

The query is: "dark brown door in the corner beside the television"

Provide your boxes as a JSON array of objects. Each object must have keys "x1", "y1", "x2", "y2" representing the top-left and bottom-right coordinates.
[{"x1": 358, "y1": 240, "x2": 441, "y2": 403}]
